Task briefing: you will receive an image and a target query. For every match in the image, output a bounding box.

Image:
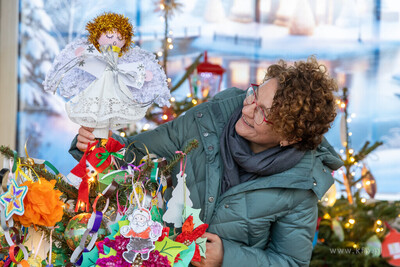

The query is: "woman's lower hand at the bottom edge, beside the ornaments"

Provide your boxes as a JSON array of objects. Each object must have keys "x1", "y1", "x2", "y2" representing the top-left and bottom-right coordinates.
[{"x1": 191, "y1": 233, "x2": 224, "y2": 267}]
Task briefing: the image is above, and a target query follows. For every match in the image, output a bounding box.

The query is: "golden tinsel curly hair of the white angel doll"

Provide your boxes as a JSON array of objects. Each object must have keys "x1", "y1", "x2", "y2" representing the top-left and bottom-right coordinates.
[{"x1": 86, "y1": 12, "x2": 133, "y2": 56}]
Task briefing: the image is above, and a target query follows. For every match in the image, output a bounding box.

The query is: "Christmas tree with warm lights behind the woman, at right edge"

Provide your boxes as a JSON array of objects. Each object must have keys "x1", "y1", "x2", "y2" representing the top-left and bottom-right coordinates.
[{"x1": 310, "y1": 88, "x2": 400, "y2": 266}]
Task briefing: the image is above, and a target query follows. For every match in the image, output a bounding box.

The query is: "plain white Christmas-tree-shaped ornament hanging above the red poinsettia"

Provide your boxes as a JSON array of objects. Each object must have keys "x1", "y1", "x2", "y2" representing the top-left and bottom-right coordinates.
[{"x1": 163, "y1": 172, "x2": 193, "y2": 228}]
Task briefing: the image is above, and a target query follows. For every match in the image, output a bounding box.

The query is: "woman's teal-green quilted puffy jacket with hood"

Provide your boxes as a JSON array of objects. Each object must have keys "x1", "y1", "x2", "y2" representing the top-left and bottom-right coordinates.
[{"x1": 70, "y1": 88, "x2": 342, "y2": 266}]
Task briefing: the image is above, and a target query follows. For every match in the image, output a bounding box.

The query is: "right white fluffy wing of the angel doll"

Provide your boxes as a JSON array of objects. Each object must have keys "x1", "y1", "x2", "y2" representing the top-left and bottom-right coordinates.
[{"x1": 119, "y1": 46, "x2": 171, "y2": 106}]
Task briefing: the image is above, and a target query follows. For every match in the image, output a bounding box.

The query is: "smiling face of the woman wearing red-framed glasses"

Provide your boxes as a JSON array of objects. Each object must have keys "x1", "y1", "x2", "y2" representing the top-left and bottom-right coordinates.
[{"x1": 235, "y1": 78, "x2": 283, "y2": 153}]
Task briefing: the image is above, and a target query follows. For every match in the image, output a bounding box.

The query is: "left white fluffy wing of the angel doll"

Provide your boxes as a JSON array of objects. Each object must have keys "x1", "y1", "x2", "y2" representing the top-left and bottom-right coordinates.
[{"x1": 43, "y1": 38, "x2": 106, "y2": 98}]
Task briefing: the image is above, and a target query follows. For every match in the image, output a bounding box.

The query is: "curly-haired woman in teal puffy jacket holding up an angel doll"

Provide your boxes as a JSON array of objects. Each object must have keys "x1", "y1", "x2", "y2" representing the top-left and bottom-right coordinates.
[{"x1": 71, "y1": 58, "x2": 342, "y2": 266}]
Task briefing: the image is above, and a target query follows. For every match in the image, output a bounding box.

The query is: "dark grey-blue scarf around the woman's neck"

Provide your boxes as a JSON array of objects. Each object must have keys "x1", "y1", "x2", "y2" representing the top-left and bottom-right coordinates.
[{"x1": 220, "y1": 107, "x2": 305, "y2": 194}]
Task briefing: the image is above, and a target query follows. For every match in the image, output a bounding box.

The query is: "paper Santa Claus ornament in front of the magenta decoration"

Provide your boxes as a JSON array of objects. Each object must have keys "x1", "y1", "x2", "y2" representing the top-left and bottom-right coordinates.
[{"x1": 120, "y1": 208, "x2": 163, "y2": 263}]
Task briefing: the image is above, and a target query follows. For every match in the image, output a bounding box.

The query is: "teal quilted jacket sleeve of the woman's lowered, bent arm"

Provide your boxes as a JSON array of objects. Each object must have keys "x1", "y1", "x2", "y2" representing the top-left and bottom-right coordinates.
[{"x1": 222, "y1": 191, "x2": 318, "y2": 267}]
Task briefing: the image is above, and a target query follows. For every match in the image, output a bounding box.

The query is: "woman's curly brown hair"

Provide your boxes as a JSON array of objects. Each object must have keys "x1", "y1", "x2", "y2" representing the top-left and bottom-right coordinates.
[{"x1": 264, "y1": 57, "x2": 337, "y2": 150}]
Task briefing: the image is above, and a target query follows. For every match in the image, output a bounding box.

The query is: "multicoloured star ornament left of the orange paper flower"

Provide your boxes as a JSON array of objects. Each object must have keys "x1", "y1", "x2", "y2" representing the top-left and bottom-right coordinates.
[{"x1": 0, "y1": 179, "x2": 28, "y2": 220}]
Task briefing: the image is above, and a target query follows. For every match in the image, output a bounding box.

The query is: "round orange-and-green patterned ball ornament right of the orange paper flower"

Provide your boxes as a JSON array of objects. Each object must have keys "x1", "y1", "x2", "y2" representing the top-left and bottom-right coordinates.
[{"x1": 64, "y1": 213, "x2": 107, "y2": 250}]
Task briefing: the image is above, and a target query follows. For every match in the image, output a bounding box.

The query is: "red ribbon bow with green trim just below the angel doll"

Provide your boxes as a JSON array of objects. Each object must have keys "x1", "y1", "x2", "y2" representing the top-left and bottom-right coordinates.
[{"x1": 67, "y1": 138, "x2": 125, "y2": 212}]
